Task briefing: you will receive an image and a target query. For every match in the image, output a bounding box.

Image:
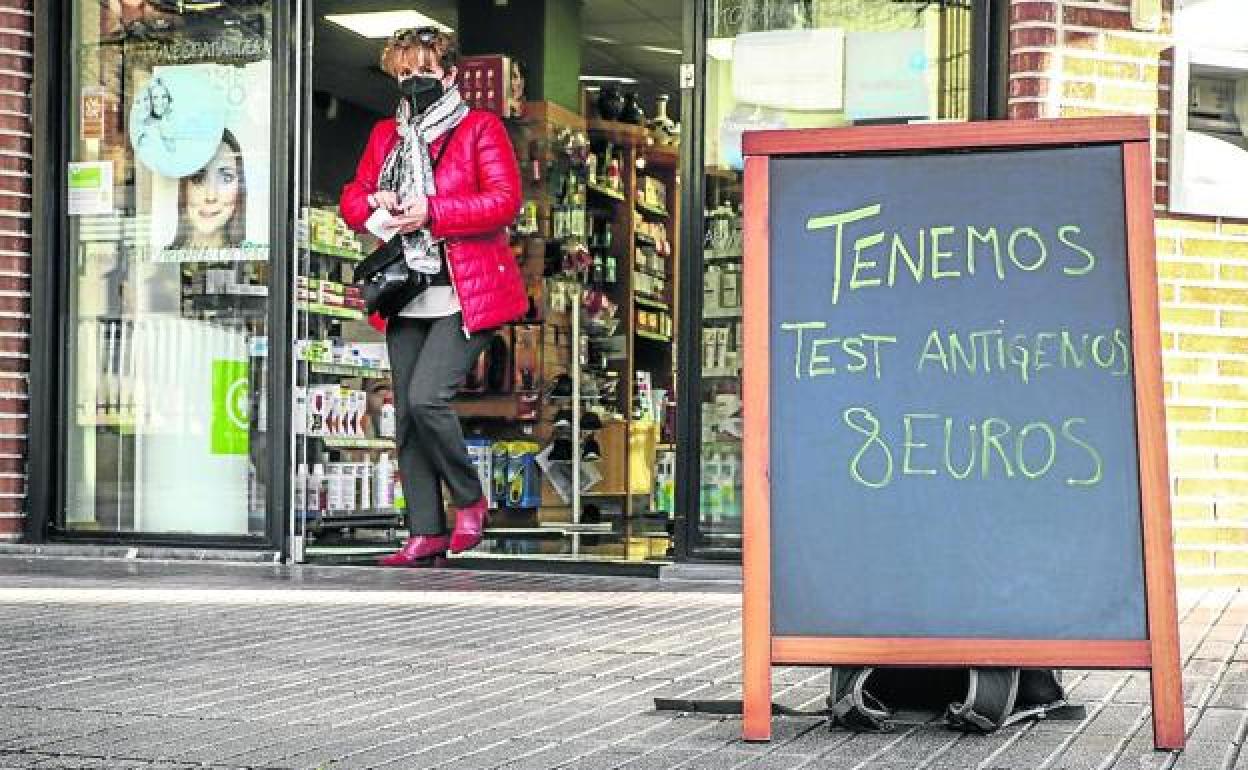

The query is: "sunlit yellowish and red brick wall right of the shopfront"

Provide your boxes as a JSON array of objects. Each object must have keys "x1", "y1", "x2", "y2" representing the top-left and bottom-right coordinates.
[{"x1": 1010, "y1": 0, "x2": 1248, "y2": 585}]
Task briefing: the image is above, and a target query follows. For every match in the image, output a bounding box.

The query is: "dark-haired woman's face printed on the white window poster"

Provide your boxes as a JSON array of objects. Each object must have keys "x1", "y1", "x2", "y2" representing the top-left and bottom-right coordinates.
[{"x1": 168, "y1": 129, "x2": 247, "y2": 248}]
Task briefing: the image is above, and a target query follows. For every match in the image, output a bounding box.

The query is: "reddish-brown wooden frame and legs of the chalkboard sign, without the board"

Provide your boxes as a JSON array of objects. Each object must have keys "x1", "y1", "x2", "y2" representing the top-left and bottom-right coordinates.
[{"x1": 741, "y1": 117, "x2": 1184, "y2": 749}]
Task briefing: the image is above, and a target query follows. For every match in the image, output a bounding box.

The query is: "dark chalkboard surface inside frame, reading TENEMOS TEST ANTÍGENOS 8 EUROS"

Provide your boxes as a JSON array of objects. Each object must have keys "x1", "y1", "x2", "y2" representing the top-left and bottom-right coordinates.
[{"x1": 770, "y1": 146, "x2": 1147, "y2": 639}]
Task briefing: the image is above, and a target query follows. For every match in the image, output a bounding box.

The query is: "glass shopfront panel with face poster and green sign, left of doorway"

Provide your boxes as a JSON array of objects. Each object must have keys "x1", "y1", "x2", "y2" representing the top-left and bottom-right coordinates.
[{"x1": 57, "y1": 0, "x2": 272, "y2": 538}]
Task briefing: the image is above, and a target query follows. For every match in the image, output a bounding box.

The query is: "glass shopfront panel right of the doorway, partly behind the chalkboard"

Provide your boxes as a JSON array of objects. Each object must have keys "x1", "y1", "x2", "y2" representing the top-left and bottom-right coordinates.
[{"x1": 685, "y1": 0, "x2": 973, "y2": 559}]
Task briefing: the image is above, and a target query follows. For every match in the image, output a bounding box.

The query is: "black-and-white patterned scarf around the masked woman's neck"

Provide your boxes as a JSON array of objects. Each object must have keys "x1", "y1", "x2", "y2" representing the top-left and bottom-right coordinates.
[{"x1": 377, "y1": 86, "x2": 468, "y2": 275}]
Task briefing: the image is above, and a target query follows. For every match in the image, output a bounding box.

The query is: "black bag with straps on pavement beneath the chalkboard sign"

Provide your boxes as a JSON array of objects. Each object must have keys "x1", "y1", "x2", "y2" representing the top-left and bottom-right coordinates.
[{"x1": 827, "y1": 666, "x2": 1082, "y2": 733}]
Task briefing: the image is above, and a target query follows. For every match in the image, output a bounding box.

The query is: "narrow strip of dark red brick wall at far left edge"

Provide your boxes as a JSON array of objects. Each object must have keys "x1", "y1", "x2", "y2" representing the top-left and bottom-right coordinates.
[{"x1": 0, "y1": 0, "x2": 28, "y2": 542}]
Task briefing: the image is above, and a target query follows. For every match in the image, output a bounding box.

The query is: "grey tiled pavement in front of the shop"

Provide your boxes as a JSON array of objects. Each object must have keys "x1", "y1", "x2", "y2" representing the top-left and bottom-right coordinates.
[{"x1": 0, "y1": 558, "x2": 1248, "y2": 770}]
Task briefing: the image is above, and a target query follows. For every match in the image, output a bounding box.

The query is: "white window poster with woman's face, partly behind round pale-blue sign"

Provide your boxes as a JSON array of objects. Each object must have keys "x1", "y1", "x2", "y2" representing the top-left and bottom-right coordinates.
[{"x1": 145, "y1": 61, "x2": 270, "y2": 261}]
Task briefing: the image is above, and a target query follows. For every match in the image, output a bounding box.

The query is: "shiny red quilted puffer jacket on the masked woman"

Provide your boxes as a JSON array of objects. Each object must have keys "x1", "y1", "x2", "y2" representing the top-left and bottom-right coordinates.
[{"x1": 338, "y1": 110, "x2": 529, "y2": 332}]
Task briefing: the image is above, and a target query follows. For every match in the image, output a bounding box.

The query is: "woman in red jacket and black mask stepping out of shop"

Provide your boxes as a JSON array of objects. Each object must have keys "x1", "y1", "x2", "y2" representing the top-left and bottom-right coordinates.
[{"x1": 339, "y1": 27, "x2": 528, "y2": 567}]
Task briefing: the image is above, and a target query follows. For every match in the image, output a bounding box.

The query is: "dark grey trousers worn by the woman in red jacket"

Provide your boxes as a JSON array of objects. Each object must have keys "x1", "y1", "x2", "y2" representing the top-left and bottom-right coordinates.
[{"x1": 386, "y1": 313, "x2": 493, "y2": 535}]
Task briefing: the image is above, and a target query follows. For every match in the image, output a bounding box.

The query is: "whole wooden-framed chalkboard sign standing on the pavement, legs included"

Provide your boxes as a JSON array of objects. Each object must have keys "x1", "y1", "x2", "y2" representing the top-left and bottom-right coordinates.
[{"x1": 744, "y1": 119, "x2": 1183, "y2": 748}]
